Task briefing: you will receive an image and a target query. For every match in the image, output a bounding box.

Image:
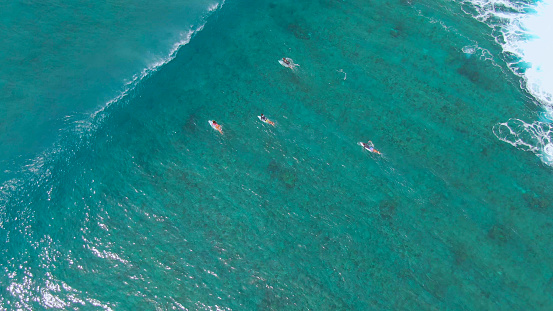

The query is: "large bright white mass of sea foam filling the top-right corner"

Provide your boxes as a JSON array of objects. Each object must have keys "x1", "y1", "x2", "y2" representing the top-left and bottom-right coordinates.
[{"x1": 461, "y1": 0, "x2": 553, "y2": 106}]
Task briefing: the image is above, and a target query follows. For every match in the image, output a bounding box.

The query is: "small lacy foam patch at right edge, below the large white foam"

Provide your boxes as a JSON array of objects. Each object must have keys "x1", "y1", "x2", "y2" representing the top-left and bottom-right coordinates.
[{"x1": 493, "y1": 119, "x2": 553, "y2": 166}]
